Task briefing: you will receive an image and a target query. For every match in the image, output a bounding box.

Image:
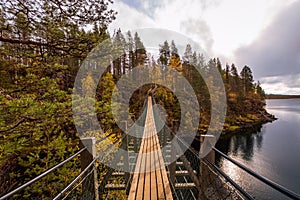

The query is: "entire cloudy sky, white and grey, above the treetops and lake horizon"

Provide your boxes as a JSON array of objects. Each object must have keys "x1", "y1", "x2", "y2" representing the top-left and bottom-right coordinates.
[{"x1": 109, "y1": 0, "x2": 300, "y2": 94}]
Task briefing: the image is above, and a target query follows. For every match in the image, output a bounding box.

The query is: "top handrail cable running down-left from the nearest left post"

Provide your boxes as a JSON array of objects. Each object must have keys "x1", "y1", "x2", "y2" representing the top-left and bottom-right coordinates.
[{"x1": 0, "y1": 147, "x2": 87, "y2": 200}]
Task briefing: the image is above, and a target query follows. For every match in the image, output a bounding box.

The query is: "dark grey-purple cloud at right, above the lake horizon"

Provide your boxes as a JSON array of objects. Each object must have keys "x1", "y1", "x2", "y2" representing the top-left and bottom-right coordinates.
[{"x1": 235, "y1": 1, "x2": 300, "y2": 80}]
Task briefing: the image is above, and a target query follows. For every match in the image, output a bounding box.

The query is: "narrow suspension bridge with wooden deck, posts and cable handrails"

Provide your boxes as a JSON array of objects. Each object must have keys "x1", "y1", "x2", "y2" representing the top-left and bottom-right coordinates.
[{"x1": 0, "y1": 96, "x2": 300, "y2": 200}]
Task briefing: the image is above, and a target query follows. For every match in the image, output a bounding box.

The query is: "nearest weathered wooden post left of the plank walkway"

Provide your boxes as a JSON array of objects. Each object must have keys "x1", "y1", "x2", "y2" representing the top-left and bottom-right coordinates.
[{"x1": 80, "y1": 137, "x2": 99, "y2": 200}]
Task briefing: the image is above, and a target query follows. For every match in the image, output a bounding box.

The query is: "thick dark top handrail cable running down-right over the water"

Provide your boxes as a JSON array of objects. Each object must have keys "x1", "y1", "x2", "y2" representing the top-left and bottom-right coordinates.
[{"x1": 212, "y1": 147, "x2": 300, "y2": 200}]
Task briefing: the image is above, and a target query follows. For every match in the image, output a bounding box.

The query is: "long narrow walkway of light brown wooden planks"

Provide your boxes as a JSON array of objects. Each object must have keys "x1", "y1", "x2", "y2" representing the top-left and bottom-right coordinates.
[{"x1": 128, "y1": 97, "x2": 173, "y2": 200}]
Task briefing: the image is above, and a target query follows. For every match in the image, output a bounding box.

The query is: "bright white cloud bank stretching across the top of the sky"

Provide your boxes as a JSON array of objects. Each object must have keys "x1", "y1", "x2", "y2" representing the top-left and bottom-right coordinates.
[{"x1": 111, "y1": 0, "x2": 294, "y2": 57}]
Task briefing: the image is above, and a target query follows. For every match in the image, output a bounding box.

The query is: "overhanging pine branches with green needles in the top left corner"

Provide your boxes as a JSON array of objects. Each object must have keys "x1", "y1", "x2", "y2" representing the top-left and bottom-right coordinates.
[{"x1": 0, "y1": 0, "x2": 116, "y2": 58}]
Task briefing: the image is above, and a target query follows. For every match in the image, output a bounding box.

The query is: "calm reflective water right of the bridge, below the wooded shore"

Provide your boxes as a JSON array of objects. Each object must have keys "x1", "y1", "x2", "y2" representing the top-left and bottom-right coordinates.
[{"x1": 216, "y1": 100, "x2": 300, "y2": 200}]
